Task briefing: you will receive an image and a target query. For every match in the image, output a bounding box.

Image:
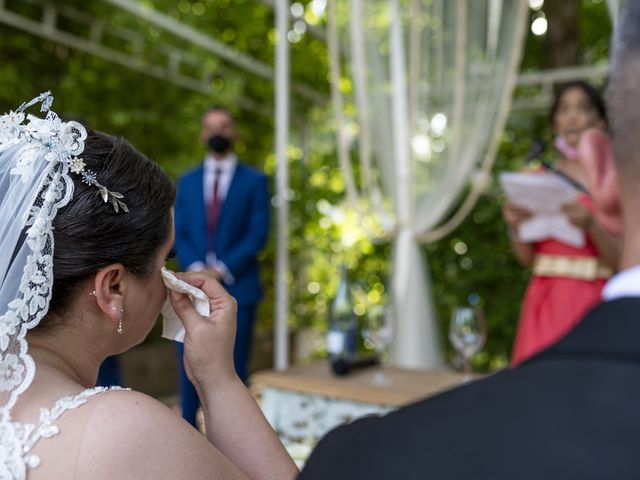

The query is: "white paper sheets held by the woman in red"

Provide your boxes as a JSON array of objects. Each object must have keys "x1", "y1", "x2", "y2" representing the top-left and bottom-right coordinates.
[{"x1": 500, "y1": 172, "x2": 586, "y2": 248}]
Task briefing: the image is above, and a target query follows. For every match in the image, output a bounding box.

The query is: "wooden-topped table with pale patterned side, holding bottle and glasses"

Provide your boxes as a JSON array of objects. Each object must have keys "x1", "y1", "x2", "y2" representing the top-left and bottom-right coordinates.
[{"x1": 250, "y1": 360, "x2": 463, "y2": 451}]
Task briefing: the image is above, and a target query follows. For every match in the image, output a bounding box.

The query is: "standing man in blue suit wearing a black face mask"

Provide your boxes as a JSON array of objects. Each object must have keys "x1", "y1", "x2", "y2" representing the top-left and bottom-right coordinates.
[{"x1": 175, "y1": 108, "x2": 269, "y2": 425}]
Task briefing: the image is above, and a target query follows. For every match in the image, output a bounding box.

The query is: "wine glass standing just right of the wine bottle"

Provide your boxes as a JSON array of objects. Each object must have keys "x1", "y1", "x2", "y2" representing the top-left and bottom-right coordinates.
[{"x1": 362, "y1": 305, "x2": 394, "y2": 386}]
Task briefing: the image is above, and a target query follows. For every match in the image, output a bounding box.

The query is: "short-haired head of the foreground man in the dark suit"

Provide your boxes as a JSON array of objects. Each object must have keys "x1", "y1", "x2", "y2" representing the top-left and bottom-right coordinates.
[{"x1": 580, "y1": 0, "x2": 640, "y2": 268}]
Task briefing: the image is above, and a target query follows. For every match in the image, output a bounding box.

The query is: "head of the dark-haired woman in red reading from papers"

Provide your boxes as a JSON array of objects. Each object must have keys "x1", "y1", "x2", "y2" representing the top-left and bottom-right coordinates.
[{"x1": 549, "y1": 81, "x2": 607, "y2": 148}]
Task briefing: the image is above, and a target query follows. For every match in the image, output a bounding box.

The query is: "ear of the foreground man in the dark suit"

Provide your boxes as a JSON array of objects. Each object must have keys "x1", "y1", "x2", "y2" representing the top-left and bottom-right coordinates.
[{"x1": 579, "y1": 129, "x2": 622, "y2": 235}]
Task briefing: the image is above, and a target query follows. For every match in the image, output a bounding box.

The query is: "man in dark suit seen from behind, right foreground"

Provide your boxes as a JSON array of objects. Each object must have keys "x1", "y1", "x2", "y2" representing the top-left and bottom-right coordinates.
[{"x1": 300, "y1": 0, "x2": 640, "y2": 480}]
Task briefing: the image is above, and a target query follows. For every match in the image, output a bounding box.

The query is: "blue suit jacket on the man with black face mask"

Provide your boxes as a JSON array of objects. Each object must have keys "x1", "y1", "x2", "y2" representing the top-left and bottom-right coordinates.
[{"x1": 175, "y1": 163, "x2": 269, "y2": 304}]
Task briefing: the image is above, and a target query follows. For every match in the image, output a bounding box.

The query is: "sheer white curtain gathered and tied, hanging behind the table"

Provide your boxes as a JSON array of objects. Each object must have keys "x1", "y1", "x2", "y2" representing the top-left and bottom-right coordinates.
[{"x1": 329, "y1": 0, "x2": 527, "y2": 367}]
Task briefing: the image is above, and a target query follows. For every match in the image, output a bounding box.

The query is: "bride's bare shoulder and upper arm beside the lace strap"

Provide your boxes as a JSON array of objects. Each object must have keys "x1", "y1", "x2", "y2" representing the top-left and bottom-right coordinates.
[{"x1": 77, "y1": 390, "x2": 245, "y2": 479}]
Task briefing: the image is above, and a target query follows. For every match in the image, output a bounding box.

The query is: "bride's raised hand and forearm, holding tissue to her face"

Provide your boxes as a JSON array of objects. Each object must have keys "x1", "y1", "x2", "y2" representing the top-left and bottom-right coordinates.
[{"x1": 170, "y1": 271, "x2": 298, "y2": 480}]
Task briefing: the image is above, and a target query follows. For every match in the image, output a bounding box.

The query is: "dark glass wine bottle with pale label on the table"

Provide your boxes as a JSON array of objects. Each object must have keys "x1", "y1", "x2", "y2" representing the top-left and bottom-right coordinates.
[{"x1": 327, "y1": 265, "x2": 358, "y2": 375}]
